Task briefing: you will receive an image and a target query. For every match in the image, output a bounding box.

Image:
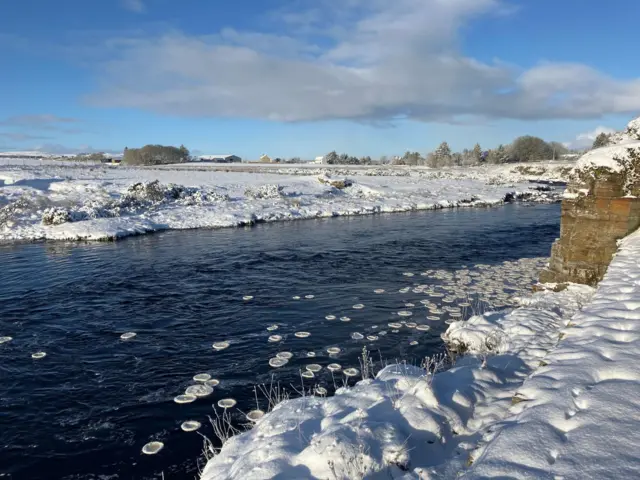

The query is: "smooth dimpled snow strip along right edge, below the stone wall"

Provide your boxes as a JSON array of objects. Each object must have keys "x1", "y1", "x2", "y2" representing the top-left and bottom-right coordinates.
[{"x1": 463, "y1": 232, "x2": 640, "y2": 480}]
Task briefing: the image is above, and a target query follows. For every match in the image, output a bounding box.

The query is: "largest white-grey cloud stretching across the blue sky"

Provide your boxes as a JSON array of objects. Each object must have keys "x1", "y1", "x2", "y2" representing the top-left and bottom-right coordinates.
[{"x1": 88, "y1": 0, "x2": 640, "y2": 122}]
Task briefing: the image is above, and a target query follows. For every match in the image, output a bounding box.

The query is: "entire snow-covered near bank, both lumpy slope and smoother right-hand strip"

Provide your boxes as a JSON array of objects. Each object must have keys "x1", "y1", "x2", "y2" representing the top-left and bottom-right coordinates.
[{"x1": 202, "y1": 228, "x2": 640, "y2": 480}]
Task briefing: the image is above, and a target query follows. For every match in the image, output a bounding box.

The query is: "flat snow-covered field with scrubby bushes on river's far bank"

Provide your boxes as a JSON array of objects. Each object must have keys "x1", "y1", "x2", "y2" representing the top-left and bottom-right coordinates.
[{"x1": 0, "y1": 159, "x2": 570, "y2": 241}]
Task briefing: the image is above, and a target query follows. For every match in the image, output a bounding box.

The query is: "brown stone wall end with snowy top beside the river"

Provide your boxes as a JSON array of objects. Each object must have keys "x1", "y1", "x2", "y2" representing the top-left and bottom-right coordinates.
[{"x1": 540, "y1": 172, "x2": 640, "y2": 285}]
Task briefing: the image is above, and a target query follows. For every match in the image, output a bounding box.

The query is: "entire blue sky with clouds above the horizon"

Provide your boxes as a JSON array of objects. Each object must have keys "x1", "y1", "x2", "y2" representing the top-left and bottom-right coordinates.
[{"x1": 0, "y1": 0, "x2": 640, "y2": 159}]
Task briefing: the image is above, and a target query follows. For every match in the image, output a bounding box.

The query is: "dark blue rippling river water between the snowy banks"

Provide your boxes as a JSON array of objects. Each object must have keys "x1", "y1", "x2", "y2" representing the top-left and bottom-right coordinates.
[{"x1": 0, "y1": 205, "x2": 559, "y2": 480}]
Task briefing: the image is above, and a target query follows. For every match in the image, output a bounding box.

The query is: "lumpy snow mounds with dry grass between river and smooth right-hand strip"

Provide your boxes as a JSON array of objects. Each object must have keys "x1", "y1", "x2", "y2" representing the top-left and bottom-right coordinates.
[{"x1": 201, "y1": 285, "x2": 593, "y2": 480}]
